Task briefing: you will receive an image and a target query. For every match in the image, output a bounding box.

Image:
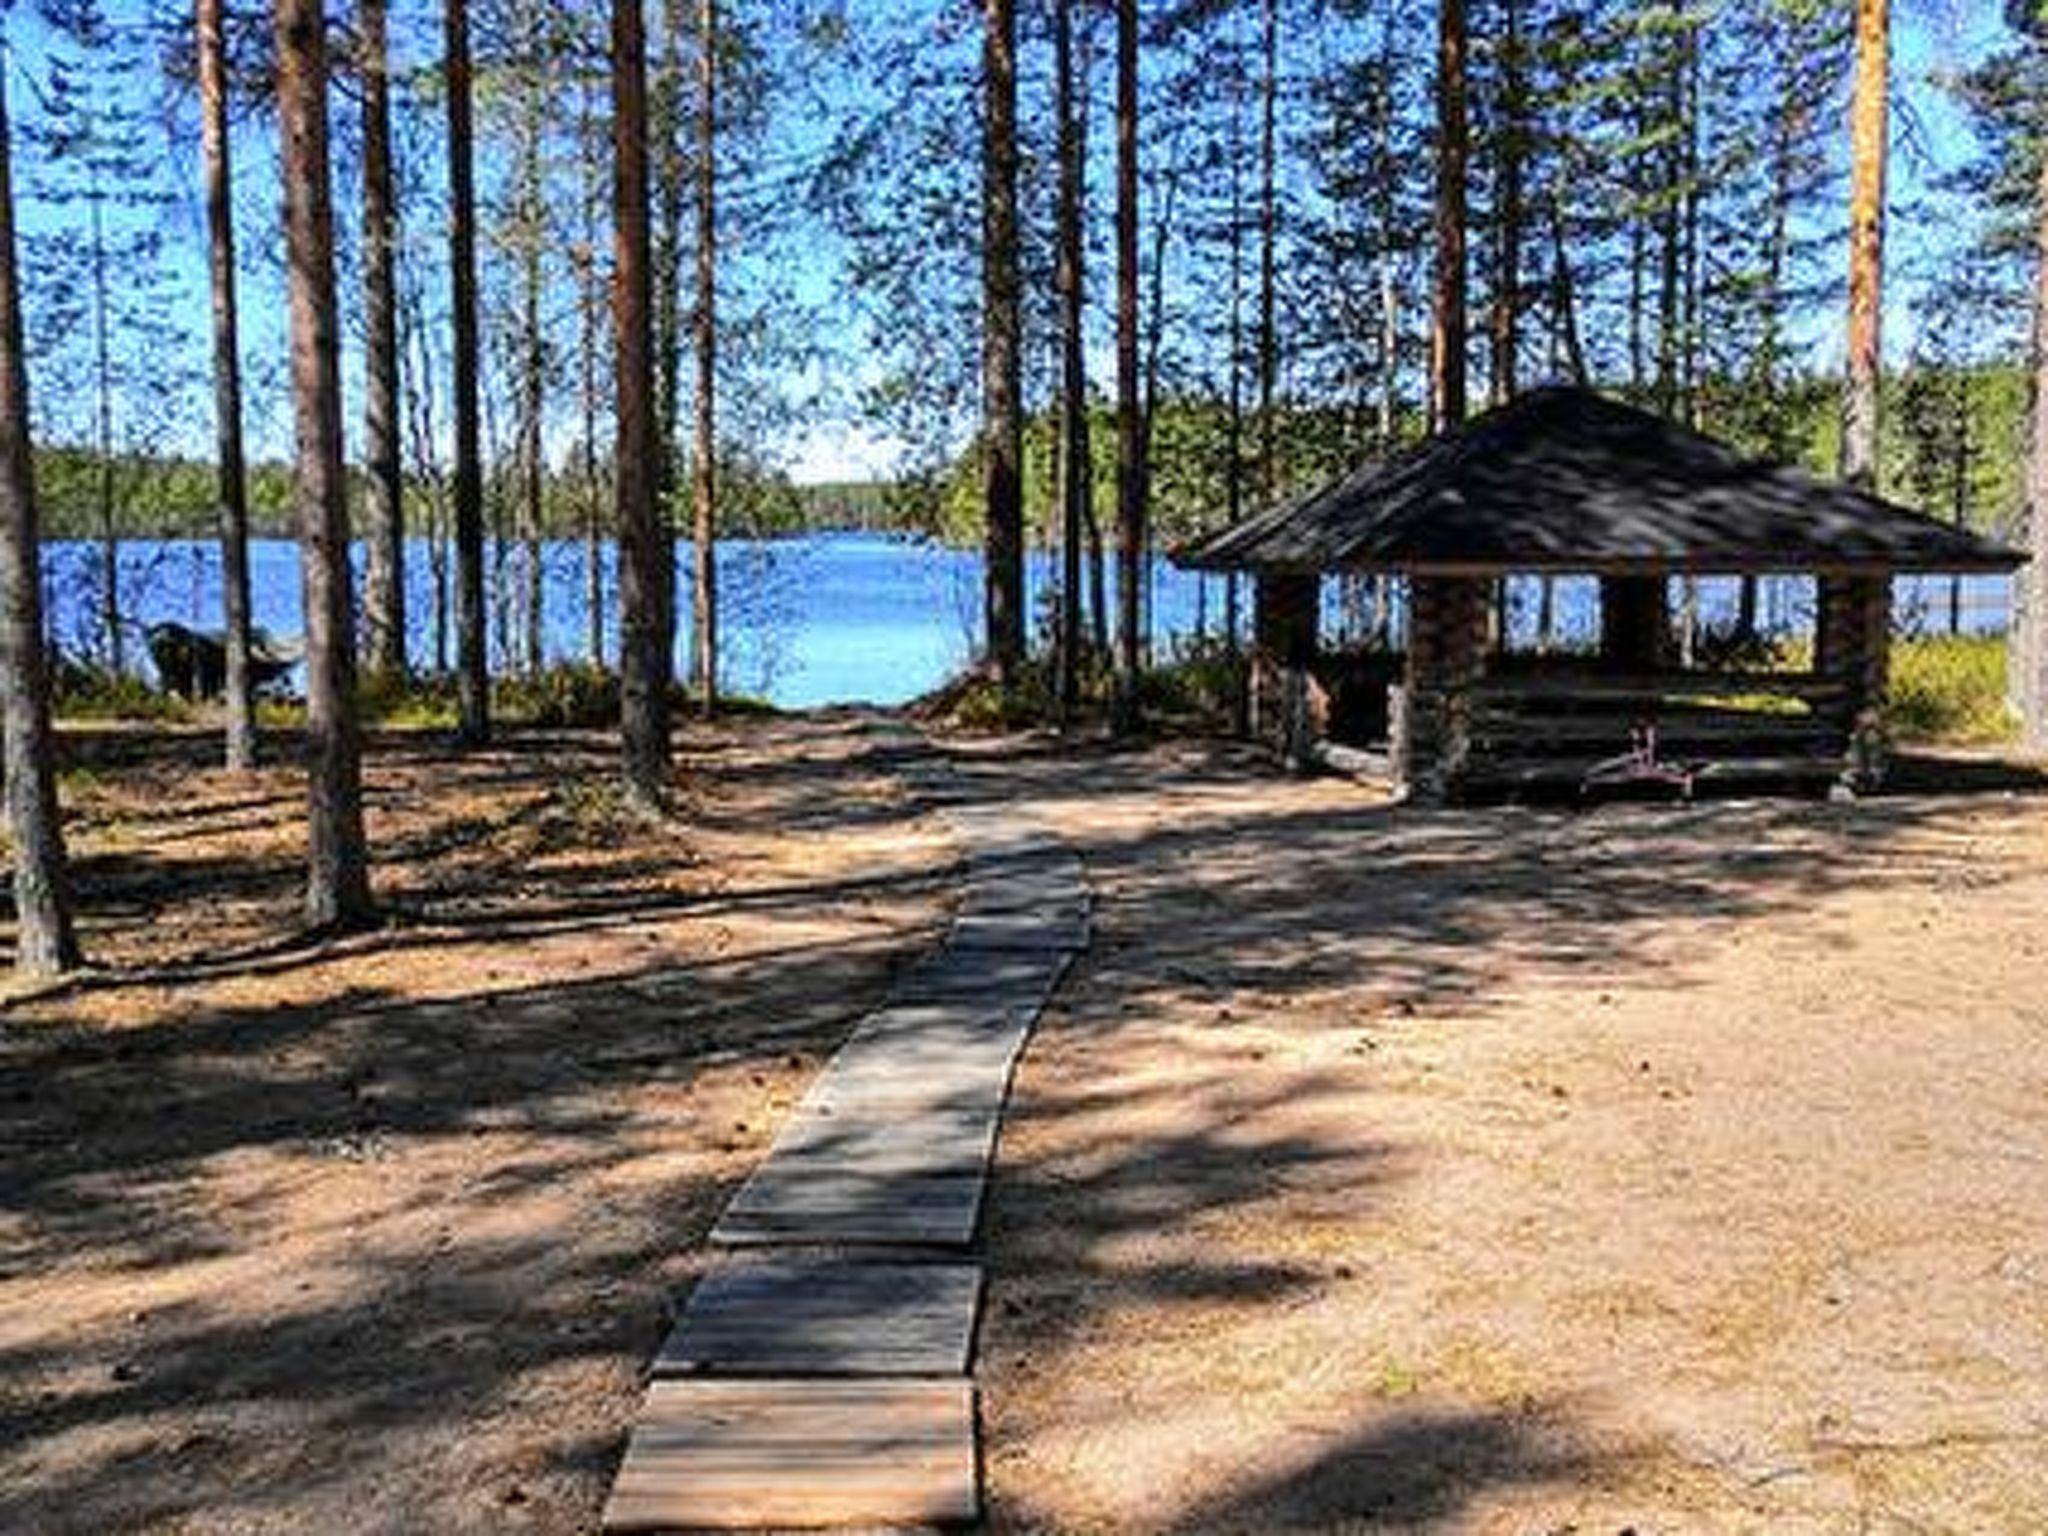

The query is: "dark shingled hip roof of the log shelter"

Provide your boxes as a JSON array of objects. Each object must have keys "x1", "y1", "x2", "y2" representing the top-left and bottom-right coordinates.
[{"x1": 1176, "y1": 387, "x2": 2025, "y2": 575}]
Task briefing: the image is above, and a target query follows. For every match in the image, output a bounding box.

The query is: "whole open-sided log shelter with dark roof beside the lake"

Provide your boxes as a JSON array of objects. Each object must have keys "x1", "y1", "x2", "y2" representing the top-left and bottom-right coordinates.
[{"x1": 1178, "y1": 387, "x2": 2023, "y2": 799}]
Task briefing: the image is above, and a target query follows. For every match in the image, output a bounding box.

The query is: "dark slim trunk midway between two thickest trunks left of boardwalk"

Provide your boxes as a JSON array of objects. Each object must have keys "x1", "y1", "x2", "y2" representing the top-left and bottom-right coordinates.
[{"x1": 442, "y1": 0, "x2": 492, "y2": 745}]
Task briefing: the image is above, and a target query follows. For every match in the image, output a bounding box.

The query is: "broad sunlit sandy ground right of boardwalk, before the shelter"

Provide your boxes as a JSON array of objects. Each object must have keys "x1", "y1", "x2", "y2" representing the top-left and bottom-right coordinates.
[{"x1": 979, "y1": 745, "x2": 2048, "y2": 1534}]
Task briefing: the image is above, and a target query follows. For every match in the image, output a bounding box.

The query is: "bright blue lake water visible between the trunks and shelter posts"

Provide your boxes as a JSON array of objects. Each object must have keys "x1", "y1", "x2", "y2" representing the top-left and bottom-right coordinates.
[{"x1": 45, "y1": 532, "x2": 2009, "y2": 709}]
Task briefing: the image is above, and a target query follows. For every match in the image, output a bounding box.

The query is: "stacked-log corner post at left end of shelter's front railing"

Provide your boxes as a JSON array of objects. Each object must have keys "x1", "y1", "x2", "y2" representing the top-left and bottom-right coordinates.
[{"x1": 1393, "y1": 575, "x2": 1491, "y2": 805}]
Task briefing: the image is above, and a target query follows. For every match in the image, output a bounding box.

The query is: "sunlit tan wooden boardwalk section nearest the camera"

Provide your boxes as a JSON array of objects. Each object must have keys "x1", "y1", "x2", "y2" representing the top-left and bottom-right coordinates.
[{"x1": 604, "y1": 1380, "x2": 981, "y2": 1532}]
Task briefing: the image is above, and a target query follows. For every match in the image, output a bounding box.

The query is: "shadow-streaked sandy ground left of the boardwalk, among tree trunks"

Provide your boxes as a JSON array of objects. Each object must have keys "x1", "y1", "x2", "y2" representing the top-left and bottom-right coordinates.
[{"x1": 0, "y1": 719, "x2": 952, "y2": 1536}]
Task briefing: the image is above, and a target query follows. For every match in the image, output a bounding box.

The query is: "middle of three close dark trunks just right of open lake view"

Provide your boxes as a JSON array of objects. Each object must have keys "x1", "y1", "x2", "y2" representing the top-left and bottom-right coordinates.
[{"x1": 1053, "y1": 0, "x2": 1094, "y2": 723}]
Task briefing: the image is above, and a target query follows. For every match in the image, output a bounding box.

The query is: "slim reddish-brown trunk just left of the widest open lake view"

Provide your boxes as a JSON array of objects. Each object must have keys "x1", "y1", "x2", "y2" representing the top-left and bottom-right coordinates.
[{"x1": 690, "y1": 0, "x2": 719, "y2": 717}]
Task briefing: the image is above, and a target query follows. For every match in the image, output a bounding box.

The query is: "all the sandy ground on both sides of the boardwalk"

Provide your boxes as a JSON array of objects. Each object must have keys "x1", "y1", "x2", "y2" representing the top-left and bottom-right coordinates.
[{"x1": 0, "y1": 719, "x2": 2048, "y2": 1536}]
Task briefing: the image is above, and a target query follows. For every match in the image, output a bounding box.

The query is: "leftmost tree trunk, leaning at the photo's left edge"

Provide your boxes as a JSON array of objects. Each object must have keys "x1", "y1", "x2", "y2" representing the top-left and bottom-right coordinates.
[{"x1": 0, "y1": 60, "x2": 78, "y2": 975}]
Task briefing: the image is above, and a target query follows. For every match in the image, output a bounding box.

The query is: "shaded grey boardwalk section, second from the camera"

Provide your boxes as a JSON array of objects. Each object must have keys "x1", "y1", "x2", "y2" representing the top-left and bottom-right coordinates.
[{"x1": 653, "y1": 1260, "x2": 981, "y2": 1376}]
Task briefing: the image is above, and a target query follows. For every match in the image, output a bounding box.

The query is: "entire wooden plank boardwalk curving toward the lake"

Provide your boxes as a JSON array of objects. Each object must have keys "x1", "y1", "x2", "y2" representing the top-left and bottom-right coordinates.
[{"x1": 604, "y1": 727, "x2": 1090, "y2": 1530}]
